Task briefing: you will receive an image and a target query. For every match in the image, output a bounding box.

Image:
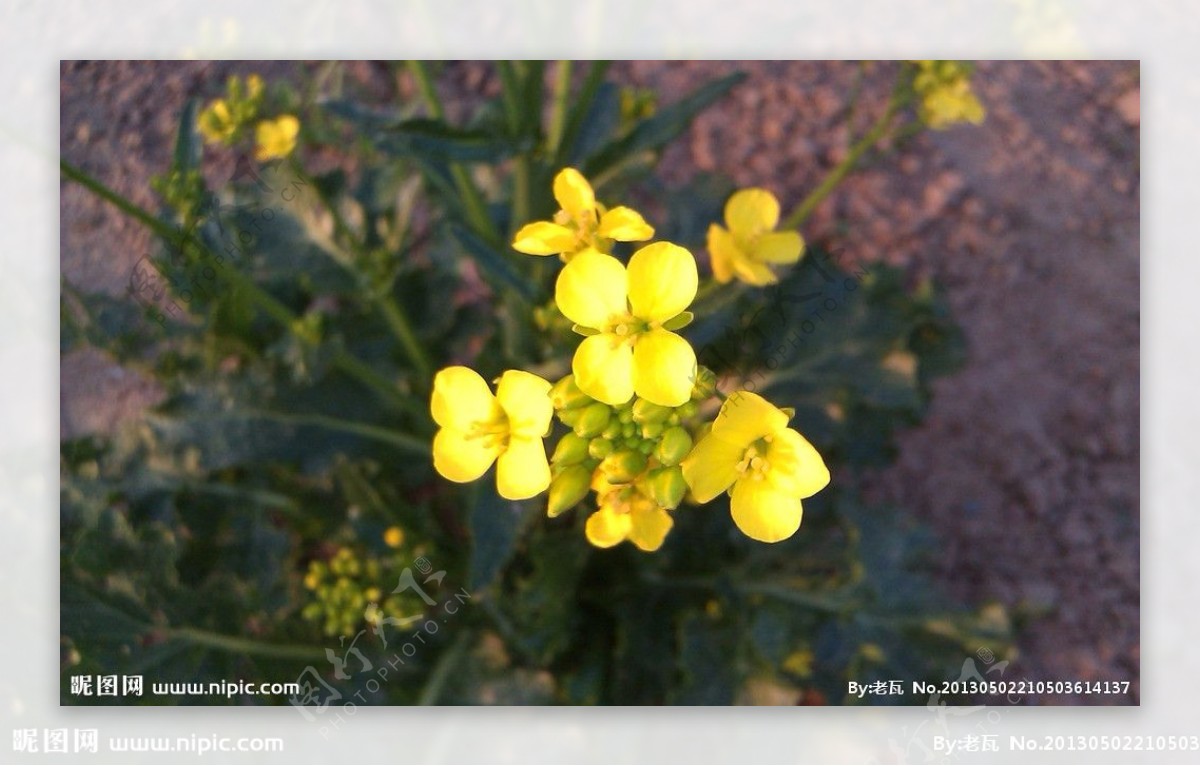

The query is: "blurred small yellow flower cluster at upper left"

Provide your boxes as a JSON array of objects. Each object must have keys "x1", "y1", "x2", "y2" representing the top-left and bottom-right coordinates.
[{"x1": 197, "y1": 74, "x2": 300, "y2": 162}]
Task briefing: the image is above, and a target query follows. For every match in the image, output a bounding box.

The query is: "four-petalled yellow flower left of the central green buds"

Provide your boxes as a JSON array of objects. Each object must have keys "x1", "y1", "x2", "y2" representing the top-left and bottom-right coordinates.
[{"x1": 430, "y1": 367, "x2": 553, "y2": 499}]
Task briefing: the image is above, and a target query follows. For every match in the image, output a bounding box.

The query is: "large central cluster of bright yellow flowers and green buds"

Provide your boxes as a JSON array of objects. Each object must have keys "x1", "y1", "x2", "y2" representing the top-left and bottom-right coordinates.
[{"x1": 431, "y1": 168, "x2": 829, "y2": 551}]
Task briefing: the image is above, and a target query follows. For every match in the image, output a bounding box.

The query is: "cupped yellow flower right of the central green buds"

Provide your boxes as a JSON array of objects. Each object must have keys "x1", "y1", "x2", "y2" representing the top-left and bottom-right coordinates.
[{"x1": 683, "y1": 391, "x2": 829, "y2": 543}]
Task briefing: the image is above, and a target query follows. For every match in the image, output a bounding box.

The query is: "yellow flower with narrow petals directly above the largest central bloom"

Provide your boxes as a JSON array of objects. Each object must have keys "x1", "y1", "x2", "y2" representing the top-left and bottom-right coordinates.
[{"x1": 512, "y1": 168, "x2": 654, "y2": 258}]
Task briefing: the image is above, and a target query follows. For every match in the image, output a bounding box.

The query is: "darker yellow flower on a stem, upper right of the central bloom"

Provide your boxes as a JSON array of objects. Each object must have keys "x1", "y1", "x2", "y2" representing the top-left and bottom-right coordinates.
[{"x1": 708, "y1": 188, "x2": 804, "y2": 287}]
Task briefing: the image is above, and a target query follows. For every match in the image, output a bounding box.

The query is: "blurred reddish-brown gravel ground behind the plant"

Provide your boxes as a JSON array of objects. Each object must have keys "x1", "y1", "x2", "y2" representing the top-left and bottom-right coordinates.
[{"x1": 60, "y1": 61, "x2": 1140, "y2": 704}]
